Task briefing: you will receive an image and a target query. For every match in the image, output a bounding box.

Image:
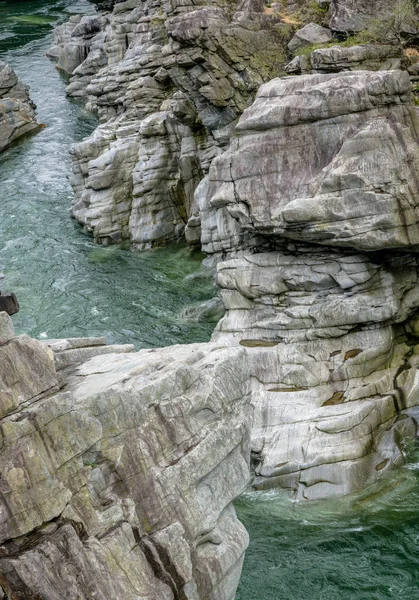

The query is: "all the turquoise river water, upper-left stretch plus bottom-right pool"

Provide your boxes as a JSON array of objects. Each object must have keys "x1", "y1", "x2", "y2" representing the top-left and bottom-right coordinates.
[{"x1": 0, "y1": 0, "x2": 419, "y2": 600}]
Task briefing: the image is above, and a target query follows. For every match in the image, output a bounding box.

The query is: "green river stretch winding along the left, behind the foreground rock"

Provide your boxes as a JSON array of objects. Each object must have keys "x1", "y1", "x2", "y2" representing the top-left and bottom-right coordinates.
[{"x1": 0, "y1": 0, "x2": 214, "y2": 348}]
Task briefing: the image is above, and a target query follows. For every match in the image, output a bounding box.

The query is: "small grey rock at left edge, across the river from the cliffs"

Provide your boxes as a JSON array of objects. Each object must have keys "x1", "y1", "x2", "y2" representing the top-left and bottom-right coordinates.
[{"x1": 0, "y1": 61, "x2": 40, "y2": 152}]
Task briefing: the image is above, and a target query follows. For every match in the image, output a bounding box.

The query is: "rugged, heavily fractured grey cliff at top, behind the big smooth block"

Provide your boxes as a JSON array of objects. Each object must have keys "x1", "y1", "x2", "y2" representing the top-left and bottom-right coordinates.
[{"x1": 50, "y1": 0, "x2": 288, "y2": 250}]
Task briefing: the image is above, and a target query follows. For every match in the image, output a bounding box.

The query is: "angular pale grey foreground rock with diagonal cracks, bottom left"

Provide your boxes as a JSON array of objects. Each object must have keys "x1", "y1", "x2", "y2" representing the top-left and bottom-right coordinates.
[{"x1": 0, "y1": 313, "x2": 251, "y2": 600}]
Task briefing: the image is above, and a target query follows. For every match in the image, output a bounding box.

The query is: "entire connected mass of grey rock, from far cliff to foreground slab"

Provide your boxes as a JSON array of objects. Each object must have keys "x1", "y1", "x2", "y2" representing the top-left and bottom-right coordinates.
[{"x1": 4, "y1": 0, "x2": 419, "y2": 600}]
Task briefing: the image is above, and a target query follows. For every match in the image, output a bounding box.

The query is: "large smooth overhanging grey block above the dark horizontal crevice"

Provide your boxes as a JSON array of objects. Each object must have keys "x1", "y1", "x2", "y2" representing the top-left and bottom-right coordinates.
[{"x1": 202, "y1": 71, "x2": 419, "y2": 252}]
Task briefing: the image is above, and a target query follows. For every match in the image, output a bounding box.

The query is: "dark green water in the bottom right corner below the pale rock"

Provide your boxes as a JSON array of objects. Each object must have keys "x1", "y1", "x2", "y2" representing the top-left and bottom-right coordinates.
[{"x1": 236, "y1": 451, "x2": 419, "y2": 600}]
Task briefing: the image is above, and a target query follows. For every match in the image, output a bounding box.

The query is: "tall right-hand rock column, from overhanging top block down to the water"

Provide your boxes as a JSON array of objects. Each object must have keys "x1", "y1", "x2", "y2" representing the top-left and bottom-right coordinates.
[{"x1": 202, "y1": 70, "x2": 419, "y2": 499}]
